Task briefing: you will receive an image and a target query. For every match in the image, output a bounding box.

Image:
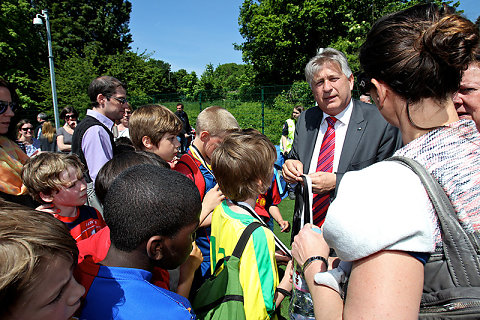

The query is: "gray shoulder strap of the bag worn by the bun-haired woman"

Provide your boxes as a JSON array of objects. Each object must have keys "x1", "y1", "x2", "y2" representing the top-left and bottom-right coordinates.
[{"x1": 387, "y1": 156, "x2": 480, "y2": 287}]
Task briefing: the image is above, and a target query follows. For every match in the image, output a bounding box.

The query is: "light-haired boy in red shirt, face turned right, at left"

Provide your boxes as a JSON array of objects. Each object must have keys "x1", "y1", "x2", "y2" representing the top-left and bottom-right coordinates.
[{"x1": 22, "y1": 152, "x2": 105, "y2": 241}]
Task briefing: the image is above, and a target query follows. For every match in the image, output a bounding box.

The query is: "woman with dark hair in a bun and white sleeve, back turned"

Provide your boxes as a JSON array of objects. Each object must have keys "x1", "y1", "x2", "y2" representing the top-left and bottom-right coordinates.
[{"x1": 292, "y1": 4, "x2": 480, "y2": 320}]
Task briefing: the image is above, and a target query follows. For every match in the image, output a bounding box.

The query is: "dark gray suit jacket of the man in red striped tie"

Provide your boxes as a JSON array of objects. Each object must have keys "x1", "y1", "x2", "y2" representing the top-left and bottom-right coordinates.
[{"x1": 289, "y1": 100, "x2": 402, "y2": 239}]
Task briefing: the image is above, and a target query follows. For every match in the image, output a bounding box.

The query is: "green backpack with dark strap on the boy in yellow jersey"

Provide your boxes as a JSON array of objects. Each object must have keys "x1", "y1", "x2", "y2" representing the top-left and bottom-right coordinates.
[{"x1": 192, "y1": 222, "x2": 261, "y2": 320}]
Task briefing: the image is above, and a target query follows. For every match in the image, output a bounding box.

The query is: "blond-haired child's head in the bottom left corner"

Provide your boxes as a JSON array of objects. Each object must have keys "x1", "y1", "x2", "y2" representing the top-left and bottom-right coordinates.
[{"x1": 0, "y1": 201, "x2": 85, "y2": 320}]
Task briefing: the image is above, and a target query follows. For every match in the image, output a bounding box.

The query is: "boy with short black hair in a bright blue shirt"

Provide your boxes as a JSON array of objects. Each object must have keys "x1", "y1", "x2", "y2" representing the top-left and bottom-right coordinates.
[{"x1": 77, "y1": 164, "x2": 201, "y2": 320}]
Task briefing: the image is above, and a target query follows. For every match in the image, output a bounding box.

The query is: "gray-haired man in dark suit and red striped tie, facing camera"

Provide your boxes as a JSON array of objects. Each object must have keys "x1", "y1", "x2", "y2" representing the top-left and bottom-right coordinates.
[{"x1": 283, "y1": 48, "x2": 402, "y2": 239}]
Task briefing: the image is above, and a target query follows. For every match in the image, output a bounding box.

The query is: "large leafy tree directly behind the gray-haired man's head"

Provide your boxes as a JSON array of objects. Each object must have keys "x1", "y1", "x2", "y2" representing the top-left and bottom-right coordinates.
[{"x1": 236, "y1": 0, "x2": 448, "y2": 85}]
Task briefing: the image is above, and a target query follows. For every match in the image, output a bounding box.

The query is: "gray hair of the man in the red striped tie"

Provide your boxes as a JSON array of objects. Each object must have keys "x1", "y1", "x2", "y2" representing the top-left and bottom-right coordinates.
[{"x1": 305, "y1": 48, "x2": 352, "y2": 87}]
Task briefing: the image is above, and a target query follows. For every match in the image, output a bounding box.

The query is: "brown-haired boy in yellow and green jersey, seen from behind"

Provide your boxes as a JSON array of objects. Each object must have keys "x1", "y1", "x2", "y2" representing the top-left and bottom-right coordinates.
[{"x1": 211, "y1": 129, "x2": 278, "y2": 320}]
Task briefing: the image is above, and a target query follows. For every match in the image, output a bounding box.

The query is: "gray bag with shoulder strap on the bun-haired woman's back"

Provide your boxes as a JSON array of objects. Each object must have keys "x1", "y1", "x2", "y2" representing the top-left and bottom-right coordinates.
[{"x1": 387, "y1": 156, "x2": 480, "y2": 319}]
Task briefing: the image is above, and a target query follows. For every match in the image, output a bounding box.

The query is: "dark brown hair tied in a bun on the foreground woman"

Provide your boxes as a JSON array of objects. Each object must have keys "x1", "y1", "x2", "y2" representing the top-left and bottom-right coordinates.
[{"x1": 360, "y1": 4, "x2": 479, "y2": 102}]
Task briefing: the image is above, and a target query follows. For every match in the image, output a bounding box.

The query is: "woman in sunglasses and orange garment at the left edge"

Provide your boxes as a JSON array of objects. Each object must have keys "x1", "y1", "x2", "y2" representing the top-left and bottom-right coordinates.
[{"x1": 0, "y1": 79, "x2": 34, "y2": 206}]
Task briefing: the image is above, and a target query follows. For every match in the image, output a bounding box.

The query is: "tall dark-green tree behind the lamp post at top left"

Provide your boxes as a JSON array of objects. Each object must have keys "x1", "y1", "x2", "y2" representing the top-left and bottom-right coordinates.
[{"x1": 0, "y1": 0, "x2": 132, "y2": 113}]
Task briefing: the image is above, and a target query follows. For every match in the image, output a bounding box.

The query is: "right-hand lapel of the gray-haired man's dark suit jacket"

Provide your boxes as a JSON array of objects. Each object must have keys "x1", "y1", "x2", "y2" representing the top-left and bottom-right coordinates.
[{"x1": 337, "y1": 100, "x2": 368, "y2": 172}]
